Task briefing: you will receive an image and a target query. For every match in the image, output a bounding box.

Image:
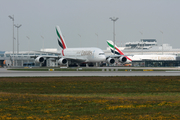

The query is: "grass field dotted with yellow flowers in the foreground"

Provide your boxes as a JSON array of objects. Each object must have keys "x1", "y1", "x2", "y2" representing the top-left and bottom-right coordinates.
[{"x1": 0, "y1": 77, "x2": 180, "y2": 120}]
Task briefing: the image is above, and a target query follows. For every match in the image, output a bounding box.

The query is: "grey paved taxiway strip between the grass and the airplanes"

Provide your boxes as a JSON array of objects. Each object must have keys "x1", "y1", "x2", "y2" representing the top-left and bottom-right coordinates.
[{"x1": 0, "y1": 68, "x2": 180, "y2": 77}]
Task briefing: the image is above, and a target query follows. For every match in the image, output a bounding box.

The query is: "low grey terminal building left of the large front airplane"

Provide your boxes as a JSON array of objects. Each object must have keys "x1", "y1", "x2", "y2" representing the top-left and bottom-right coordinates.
[{"x1": 0, "y1": 51, "x2": 58, "y2": 67}]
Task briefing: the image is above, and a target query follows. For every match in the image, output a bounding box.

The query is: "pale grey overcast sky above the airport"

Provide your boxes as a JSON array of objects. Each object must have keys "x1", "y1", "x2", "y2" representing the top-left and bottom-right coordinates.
[{"x1": 0, "y1": 0, "x2": 180, "y2": 51}]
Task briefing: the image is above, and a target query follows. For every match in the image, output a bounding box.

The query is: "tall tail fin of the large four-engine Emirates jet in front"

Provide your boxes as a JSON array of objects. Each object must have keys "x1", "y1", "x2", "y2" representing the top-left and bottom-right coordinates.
[{"x1": 56, "y1": 26, "x2": 67, "y2": 49}]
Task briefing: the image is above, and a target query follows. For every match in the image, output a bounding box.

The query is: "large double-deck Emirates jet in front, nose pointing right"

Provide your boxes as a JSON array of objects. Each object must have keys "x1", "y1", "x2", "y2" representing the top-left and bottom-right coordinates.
[{"x1": 35, "y1": 26, "x2": 109, "y2": 65}]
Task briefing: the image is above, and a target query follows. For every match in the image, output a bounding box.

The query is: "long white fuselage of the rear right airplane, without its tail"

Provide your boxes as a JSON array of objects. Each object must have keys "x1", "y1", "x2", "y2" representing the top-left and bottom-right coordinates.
[{"x1": 127, "y1": 55, "x2": 176, "y2": 62}]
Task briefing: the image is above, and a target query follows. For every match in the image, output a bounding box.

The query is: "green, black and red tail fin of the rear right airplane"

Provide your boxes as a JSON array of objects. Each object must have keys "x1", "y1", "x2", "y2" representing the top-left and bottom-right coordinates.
[{"x1": 107, "y1": 40, "x2": 132, "y2": 61}]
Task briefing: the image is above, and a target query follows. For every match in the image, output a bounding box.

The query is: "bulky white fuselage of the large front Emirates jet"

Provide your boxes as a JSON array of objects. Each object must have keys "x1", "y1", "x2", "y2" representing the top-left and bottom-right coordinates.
[{"x1": 62, "y1": 48, "x2": 106, "y2": 62}]
